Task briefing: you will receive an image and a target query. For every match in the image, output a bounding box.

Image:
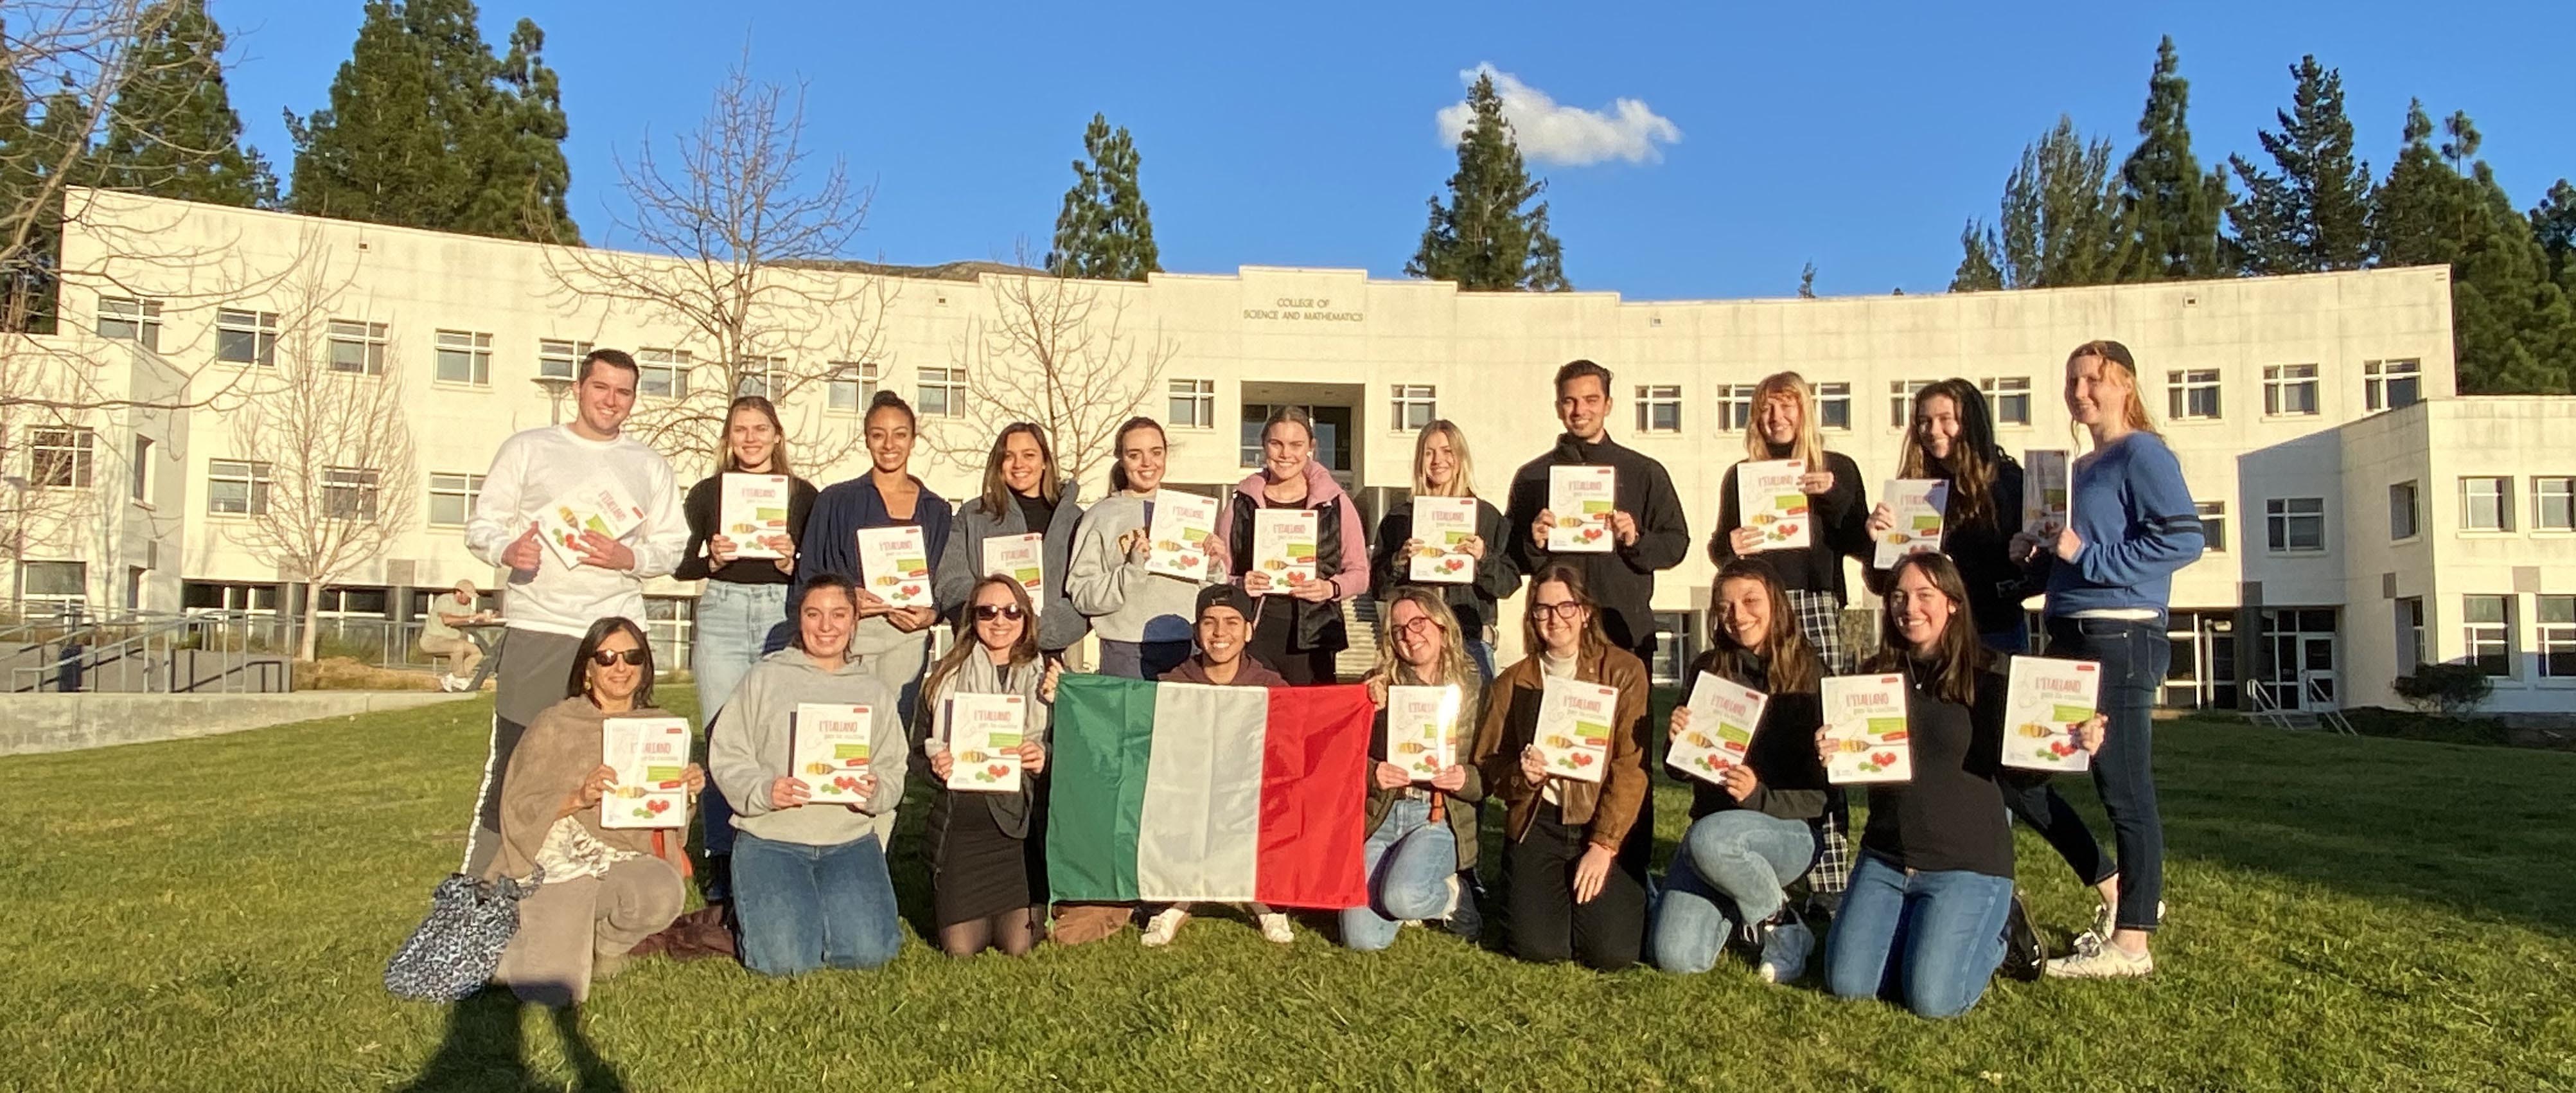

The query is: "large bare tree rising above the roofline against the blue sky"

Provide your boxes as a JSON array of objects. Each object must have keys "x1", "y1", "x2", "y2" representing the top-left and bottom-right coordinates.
[{"x1": 549, "y1": 54, "x2": 888, "y2": 467}]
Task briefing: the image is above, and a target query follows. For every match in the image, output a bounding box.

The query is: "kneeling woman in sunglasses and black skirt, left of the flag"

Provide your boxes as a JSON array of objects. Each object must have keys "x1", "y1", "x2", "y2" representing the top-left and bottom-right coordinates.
[{"x1": 922, "y1": 578, "x2": 1061, "y2": 956}]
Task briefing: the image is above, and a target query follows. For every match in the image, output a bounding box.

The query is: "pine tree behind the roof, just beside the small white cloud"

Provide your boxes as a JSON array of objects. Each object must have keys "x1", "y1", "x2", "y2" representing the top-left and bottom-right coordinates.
[{"x1": 1404, "y1": 75, "x2": 1571, "y2": 291}]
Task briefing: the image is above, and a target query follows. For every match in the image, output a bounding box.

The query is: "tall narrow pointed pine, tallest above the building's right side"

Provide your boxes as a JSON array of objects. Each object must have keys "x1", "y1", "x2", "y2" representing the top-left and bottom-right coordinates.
[{"x1": 2120, "y1": 36, "x2": 2228, "y2": 281}]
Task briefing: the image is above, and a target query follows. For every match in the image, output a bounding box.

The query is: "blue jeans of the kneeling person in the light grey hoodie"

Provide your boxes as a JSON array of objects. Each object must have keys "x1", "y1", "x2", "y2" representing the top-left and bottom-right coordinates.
[{"x1": 734, "y1": 833, "x2": 904, "y2": 974}]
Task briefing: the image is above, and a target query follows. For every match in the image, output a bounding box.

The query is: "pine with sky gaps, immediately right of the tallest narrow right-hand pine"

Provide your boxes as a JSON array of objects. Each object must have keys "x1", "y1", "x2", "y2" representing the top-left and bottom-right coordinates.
[{"x1": 2228, "y1": 54, "x2": 2370, "y2": 273}]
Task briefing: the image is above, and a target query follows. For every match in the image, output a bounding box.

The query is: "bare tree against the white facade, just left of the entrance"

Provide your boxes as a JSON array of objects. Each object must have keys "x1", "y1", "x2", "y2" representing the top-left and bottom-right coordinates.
[{"x1": 925, "y1": 245, "x2": 1180, "y2": 482}]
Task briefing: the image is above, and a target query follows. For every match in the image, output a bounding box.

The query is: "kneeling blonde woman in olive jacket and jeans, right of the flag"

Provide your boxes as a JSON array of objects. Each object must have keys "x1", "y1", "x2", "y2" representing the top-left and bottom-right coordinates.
[{"x1": 1342, "y1": 585, "x2": 1484, "y2": 948}]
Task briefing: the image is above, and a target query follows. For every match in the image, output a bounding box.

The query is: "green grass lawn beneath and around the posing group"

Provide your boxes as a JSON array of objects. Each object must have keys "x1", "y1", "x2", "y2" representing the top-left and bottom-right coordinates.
[{"x1": 0, "y1": 691, "x2": 2576, "y2": 1093}]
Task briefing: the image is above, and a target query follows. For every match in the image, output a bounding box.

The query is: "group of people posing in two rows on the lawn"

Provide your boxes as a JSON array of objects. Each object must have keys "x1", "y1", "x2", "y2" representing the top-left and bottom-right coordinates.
[{"x1": 466, "y1": 341, "x2": 2200, "y2": 1016}]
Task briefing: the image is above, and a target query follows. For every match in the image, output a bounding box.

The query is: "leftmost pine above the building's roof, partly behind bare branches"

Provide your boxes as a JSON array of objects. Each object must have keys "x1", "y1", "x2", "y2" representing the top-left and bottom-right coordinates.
[{"x1": 95, "y1": 0, "x2": 278, "y2": 209}]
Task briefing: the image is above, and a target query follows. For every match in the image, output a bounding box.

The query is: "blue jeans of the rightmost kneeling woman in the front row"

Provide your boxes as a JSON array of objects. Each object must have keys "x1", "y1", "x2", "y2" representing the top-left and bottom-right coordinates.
[{"x1": 1824, "y1": 853, "x2": 2012, "y2": 1018}]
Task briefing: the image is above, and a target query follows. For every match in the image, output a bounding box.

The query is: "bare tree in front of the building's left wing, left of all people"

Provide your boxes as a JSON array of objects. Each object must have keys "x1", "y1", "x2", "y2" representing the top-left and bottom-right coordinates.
[{"x1": 229, "y1": 255, "x2": 420, "y2": 660}]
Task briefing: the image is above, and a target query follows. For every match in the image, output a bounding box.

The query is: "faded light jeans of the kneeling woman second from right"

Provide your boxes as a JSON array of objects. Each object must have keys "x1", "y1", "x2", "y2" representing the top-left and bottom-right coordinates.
[{"x1": 1646, "y1": 810, "x2": 1821, "y2": 974}]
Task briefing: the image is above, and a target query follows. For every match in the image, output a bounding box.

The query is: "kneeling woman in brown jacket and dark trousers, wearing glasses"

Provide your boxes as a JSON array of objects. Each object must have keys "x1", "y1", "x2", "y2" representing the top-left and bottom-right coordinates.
[{"x1": 1476, "y1": 565, "x2": 1654, "y2": 972}]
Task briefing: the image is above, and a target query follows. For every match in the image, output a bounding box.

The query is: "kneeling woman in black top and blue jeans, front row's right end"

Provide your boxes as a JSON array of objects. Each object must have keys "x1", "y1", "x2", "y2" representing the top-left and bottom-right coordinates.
[{"x1": 1816, "y1": 555, "x2": 2104, "y2": 1018}]
